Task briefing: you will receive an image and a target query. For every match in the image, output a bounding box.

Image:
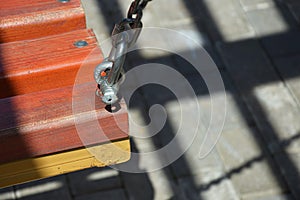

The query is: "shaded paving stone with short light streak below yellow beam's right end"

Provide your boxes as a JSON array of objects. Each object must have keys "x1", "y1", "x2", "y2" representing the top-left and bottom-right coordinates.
[{"x1": 67, "y1": 167, "x2": 121, "y2": 196}]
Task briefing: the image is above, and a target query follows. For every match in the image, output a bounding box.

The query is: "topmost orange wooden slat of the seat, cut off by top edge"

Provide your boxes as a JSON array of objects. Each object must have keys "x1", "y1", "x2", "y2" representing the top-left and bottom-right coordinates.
[{"x1": 0, "y1": 0, "x2": 86, "y2": 43}]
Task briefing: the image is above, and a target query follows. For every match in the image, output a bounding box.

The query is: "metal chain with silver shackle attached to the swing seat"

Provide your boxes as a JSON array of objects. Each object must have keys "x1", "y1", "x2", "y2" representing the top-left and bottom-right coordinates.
[{"x1": 94, "y1": 0, "x2": 151, "y2": 105}]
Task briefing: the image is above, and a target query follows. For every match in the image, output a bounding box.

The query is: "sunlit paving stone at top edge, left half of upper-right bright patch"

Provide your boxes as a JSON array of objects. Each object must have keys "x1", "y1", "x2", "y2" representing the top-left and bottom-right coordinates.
[{"x1": 199, "y1": 0, "x2": 255, "y2": 42}]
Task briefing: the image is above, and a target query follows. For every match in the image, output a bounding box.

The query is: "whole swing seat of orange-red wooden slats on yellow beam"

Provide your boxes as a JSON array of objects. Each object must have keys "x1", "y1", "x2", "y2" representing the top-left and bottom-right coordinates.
[{"x1": 0, "y1": 0, "x2": 130, "y2": 187}]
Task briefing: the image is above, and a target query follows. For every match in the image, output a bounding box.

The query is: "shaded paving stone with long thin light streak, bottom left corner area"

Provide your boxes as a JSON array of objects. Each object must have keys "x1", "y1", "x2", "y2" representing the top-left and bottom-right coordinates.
[{"x1": 15, "y1": 176, "x2": 71, "y2": 200}]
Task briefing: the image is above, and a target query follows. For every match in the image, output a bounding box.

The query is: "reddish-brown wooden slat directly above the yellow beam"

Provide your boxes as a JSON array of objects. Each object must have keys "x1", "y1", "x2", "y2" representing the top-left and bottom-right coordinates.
[{"x1": 0, "y1": 82, "x2": 128, "y2": 164}]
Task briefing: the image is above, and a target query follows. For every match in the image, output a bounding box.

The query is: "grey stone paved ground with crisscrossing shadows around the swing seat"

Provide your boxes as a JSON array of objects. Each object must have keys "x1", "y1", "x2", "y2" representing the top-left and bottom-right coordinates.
[{"x1": 0, "y1": 0, "x2": 300, "y2": 200}]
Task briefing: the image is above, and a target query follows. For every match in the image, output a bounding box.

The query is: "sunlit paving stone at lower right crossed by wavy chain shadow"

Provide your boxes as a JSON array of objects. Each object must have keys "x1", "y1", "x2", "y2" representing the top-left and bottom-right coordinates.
[{"x1": 217, "y1": 128, "x2": 286, "y2": 195}]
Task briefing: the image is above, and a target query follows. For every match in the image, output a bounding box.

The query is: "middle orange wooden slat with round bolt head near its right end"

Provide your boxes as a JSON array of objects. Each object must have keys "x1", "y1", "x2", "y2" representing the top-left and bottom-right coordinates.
[{"x1": 0, "y1": 29, "x2": 103, "y2": 98}]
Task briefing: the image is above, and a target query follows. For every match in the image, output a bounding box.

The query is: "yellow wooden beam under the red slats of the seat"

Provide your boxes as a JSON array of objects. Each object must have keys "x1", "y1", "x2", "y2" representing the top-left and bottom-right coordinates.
[{"x1": 0, "y1": 139, "x2": 130, "y2": 188}]
